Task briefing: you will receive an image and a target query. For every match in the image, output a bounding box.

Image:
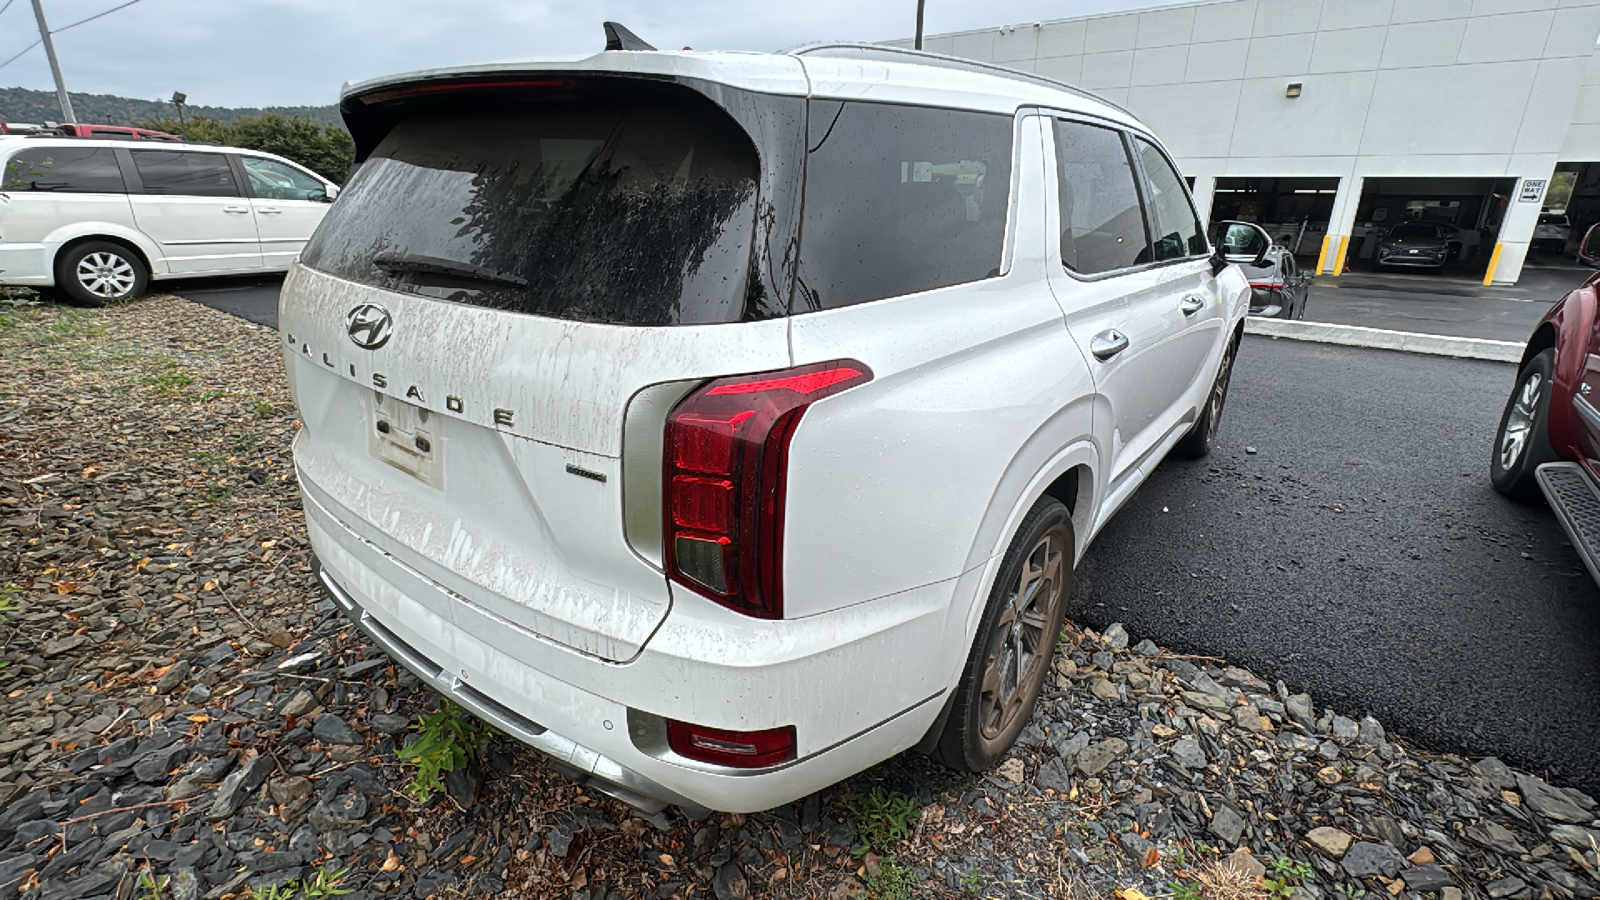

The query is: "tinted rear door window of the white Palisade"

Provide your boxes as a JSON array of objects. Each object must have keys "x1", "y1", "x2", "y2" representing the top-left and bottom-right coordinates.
[{"x1": 1056, "y1": 119, "x2": 1150, "y2": 275}]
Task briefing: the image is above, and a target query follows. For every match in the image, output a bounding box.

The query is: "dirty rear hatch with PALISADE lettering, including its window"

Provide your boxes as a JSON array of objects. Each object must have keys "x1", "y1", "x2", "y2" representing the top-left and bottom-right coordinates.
[{"x1": 280, "y1": 74, "x2": 803, "y2": 660}]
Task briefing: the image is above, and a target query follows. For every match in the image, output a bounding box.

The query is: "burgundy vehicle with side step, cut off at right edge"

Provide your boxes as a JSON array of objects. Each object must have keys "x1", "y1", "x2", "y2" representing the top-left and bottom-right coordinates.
[{"x1": 1490, "y1": 231, "x2": 1600, "y2": 581}]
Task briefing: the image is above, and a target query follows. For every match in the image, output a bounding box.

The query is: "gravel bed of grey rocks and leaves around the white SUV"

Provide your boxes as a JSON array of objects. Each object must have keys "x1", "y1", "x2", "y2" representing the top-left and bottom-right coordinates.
[{"x1": 0, "y1": 298, "x2": 1600, "y2": 900}]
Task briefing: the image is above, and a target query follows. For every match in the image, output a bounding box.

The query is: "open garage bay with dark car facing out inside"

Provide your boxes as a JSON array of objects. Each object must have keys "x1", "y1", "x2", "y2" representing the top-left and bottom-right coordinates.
[{"x1": 1346, "y1": 178, "x2": 1517, "y2": 275}]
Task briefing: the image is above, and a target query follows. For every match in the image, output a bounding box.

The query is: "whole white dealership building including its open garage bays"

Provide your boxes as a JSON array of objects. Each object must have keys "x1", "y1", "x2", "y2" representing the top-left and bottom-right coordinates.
[{"x1": 893, "y1": 0, "x2": 1600, "y2": 283}]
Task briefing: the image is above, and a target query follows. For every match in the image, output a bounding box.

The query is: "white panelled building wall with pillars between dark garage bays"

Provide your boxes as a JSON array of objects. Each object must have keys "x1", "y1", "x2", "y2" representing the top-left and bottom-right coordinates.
[{"x1": 893, "y1": 0, "x2": 1600, "y2": 283}]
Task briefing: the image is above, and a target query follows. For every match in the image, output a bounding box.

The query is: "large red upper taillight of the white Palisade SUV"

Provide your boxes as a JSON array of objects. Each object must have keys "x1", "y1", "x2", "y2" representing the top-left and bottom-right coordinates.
[{"x1": 662, "y1": 359, "x2": 872, "y2": 618}]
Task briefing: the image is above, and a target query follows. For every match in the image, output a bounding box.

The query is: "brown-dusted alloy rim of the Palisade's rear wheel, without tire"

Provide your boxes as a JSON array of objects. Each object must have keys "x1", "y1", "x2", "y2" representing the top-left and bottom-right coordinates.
[{"x1": 978, "y1": 524, "x2": 1067, "y2": 741}]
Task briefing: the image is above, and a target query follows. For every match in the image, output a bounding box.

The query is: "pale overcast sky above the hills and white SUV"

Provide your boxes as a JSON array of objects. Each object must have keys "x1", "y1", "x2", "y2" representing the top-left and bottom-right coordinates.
[{"x1": 0, "y1": 0, "x2": 1160, "y2": 106}]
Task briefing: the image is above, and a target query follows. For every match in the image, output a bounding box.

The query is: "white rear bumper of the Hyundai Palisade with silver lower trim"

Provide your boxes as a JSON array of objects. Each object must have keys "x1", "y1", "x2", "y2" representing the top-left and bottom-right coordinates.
[{"x1": 302, "y1": 472, "x2": 963, "y2": 812}]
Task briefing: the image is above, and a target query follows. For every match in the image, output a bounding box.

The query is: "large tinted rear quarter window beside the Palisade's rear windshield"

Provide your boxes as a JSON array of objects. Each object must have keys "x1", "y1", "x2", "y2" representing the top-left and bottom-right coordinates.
[{"x1": 795, "y1": 101, "x2": 1011, "y2": 312}]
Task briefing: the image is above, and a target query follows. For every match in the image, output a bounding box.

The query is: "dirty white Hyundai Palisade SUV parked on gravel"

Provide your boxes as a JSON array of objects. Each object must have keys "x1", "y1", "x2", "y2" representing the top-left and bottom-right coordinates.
[{"x1": 278, "y1": 40, "x2": 1269, "y2": 810}]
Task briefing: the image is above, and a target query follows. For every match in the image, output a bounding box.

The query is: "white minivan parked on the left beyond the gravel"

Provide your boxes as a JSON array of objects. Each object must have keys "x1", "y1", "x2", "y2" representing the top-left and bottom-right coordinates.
[{"x1": 0, "y1": 136, "x2": 339, "y2": 306}]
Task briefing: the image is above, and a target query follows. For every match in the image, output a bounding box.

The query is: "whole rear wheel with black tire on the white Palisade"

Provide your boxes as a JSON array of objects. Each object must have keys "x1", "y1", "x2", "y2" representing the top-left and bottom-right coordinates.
[{"x1": 933, "y1": 496, "x2": 1075, "y2": 772}]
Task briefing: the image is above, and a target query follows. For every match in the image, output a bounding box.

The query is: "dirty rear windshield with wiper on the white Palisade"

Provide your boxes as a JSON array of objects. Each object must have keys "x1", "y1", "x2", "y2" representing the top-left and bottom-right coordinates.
[{"x1": 301, "y1": 91, "x2": 758, "y2": 325}]
